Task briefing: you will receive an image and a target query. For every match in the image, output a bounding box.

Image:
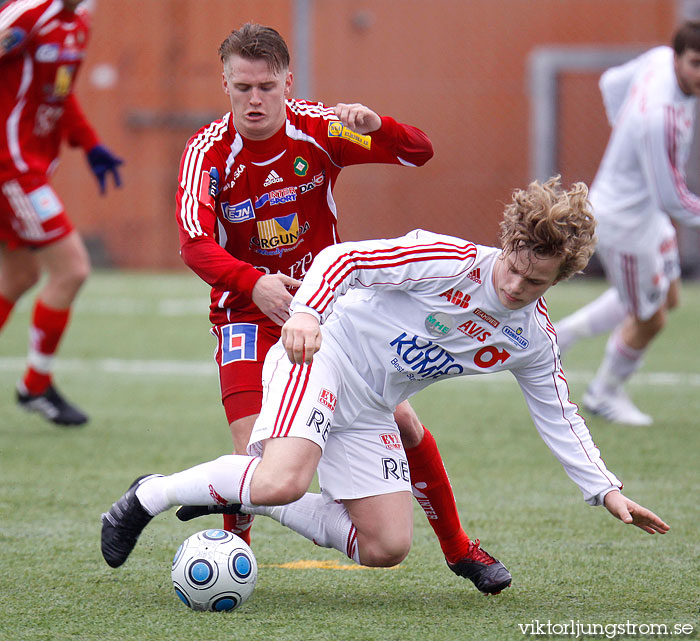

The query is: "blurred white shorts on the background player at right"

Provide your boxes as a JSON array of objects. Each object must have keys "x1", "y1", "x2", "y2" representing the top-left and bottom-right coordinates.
[{"x1": 598, "y1": 221, "x2": 681, "y2": 320}]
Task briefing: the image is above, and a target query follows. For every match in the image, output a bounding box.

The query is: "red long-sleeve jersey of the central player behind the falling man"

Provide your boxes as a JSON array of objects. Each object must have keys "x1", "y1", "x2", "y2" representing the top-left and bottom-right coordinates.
[{"x1": 176, "y1": 100, "x2": 433, "y2": 325}]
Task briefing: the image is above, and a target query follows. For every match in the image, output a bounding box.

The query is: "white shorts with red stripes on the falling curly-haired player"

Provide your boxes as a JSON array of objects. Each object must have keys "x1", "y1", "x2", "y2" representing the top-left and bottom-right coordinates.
[{"x1": 248, "y1": 335, "x2": 411, "y2": 500}]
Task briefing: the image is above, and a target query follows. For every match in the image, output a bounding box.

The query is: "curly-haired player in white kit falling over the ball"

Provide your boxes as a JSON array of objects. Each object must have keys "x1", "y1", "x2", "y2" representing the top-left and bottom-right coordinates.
[{"x1": 102, "y1": 179, "x2": 668, "y2": 592}]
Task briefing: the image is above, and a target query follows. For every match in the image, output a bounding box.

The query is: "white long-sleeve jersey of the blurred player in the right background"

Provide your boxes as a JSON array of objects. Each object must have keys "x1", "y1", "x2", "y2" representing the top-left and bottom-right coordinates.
[{"x1": 590, "y1": 47, "x2": 700, "y2": 250}]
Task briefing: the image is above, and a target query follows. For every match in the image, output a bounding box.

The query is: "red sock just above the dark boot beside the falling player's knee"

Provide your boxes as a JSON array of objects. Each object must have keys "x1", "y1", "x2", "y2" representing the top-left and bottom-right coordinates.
[{"x1": 406, "y1": 426, "x2": 470, "y2": 563}]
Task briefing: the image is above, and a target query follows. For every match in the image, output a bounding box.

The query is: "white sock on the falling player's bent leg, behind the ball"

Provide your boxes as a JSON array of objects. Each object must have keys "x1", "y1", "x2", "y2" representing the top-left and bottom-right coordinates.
[{"x1": 242, "y1": 492, "x2": 360, "y2": 563}]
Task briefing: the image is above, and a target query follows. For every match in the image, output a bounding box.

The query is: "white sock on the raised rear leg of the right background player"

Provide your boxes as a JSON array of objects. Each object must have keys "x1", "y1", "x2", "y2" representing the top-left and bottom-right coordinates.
[{"x1": 554, "y1": 287, "x2": 627, "y2": 353}]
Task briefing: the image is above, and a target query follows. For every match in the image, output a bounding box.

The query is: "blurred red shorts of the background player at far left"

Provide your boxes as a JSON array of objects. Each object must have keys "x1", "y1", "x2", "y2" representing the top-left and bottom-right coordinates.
[{"x1": 0, "y1": 174, "x2": 73, "y2": 249}]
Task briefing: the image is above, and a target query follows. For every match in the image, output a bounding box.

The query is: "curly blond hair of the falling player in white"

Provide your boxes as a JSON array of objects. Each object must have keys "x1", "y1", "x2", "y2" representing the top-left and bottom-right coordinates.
[{"x1": 501, "y1": 176, "x2": 596, "y2": 280}]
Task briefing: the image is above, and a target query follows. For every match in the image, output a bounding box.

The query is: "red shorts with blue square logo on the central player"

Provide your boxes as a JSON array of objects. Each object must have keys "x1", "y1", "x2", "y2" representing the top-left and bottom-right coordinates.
[{"x1": 211, "y1": 323, "x2": 281, "y2": 423}]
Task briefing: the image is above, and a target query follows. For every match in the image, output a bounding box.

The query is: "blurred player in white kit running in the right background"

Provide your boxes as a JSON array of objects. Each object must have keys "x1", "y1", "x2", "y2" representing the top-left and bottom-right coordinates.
[{"x1": 556, "y1": 22, "x2": 700, "y2": 425}]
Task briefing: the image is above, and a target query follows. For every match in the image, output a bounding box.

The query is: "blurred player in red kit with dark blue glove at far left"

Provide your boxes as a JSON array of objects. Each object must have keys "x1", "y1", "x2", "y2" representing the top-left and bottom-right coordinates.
[{"x1": 0, "y1": 0, "x2": 122, "y2": 425}]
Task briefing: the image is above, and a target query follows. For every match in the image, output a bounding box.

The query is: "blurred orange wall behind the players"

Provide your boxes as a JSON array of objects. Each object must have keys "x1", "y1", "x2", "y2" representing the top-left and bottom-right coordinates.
[{"x1": 55, "y1": 0, "x2": 676, "y2": 269}]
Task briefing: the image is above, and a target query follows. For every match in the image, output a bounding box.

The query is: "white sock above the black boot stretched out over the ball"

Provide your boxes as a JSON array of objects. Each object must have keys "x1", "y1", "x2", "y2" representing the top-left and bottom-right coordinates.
[{"x1": 136, "y1": 454, "x2": 260, "y2": 516}]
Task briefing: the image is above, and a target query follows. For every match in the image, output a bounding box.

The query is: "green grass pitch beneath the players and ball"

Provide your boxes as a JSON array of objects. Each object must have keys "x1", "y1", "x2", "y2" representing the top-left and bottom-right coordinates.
[{"x1": 0, "y1": 272, "x2": 700, "y2": 641}]
